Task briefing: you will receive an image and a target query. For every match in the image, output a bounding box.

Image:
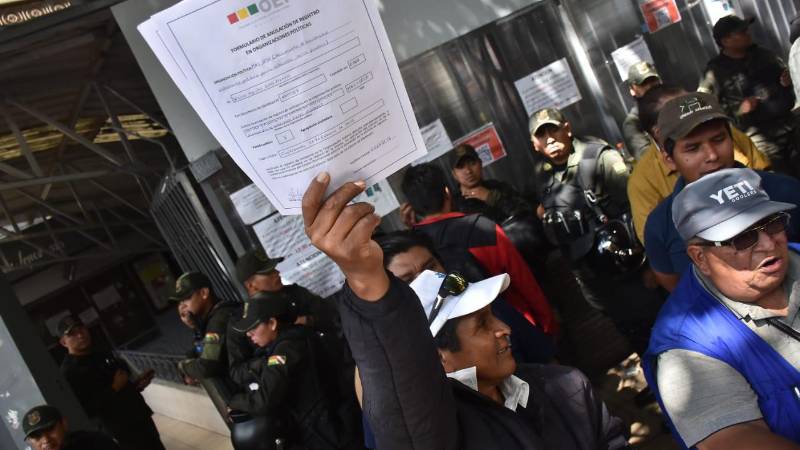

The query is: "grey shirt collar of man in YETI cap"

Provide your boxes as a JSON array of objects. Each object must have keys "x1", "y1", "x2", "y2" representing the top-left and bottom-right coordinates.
[{"x1": 692, "y1": 250, "x2": 800, "y2": 321}]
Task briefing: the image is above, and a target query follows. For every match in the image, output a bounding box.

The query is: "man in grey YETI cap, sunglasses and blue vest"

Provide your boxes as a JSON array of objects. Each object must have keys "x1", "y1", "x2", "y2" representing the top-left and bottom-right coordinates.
[{"x1": 644, "y1": 169, "x2": 800, "y2": 450}]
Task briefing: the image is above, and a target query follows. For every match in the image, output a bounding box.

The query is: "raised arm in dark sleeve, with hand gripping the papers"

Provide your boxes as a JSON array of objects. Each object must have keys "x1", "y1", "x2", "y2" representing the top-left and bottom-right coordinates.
[{"x1": 303, "y1": 174, "x2": 458, "y2": 450}]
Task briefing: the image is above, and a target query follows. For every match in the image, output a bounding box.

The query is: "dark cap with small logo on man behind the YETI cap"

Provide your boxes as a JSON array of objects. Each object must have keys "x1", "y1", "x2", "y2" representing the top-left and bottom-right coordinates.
[{"x1": 656, "y1": 92, "x2": 730, "y2": 143}]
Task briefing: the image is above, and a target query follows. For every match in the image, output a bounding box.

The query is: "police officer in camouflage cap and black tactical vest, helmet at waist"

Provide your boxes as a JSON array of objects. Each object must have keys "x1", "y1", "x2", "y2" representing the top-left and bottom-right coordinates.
[{"x1": 529, "y1": 108, "x2": 663, "y2": 352}]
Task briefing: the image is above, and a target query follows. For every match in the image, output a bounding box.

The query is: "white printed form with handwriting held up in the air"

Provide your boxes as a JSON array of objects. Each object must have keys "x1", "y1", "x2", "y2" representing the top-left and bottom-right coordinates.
[{"x1": 151, "y1": 0, "x2": 425, "y2": 214}]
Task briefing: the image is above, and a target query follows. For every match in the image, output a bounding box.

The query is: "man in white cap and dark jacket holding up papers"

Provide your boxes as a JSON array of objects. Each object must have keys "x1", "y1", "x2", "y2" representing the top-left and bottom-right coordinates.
[{"x1": 296, "y1": 173, "x2": 627, "y2": 450}]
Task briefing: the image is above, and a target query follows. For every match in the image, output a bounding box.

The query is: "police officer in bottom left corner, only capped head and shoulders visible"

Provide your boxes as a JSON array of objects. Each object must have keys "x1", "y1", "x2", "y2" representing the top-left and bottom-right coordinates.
[{"x1": 22, "y1": 405, "x2": 119, "y2": 450}]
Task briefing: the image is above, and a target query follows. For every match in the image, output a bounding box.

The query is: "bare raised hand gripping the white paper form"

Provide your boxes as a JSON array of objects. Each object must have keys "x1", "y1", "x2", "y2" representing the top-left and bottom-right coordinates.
[{"x1": 302, "y1": 172, "x2": 389, "y2": 301}]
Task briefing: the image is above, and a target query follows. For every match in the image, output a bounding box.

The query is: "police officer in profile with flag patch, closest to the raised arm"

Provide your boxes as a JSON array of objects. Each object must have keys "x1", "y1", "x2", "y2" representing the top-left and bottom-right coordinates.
[{"x1": 229, "y1": 291, "x2": 357, "y2": 450}]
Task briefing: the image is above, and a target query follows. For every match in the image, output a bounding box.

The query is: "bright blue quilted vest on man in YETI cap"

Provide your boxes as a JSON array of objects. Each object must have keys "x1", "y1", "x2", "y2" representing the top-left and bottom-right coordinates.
[{"x1": 642, "y1": 244, "x2": 800, "y2": 448}]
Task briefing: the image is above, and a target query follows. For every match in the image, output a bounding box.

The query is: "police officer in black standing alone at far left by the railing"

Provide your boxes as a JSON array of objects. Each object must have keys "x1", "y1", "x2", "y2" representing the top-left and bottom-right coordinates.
[{"x1": 57, "y1": 316, "x2": 164, "y2": 450}]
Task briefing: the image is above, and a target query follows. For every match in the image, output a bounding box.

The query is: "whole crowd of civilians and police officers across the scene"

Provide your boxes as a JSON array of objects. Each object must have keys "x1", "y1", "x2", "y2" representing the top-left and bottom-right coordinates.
[{"x1": 23, "y1": 12, "x2": 800, "y2": 450}]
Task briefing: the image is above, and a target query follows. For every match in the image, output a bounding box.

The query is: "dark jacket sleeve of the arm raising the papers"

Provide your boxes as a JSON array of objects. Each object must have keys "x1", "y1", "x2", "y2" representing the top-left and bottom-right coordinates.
[{"x1": 337, "y1": 274, "x2": 459, "y2": 450}]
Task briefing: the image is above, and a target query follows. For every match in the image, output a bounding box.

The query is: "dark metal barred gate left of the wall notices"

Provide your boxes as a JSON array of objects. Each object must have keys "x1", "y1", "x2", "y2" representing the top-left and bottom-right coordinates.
[{"x1": 150, "y1": 171, "x2": 243, "y2": 299}]
